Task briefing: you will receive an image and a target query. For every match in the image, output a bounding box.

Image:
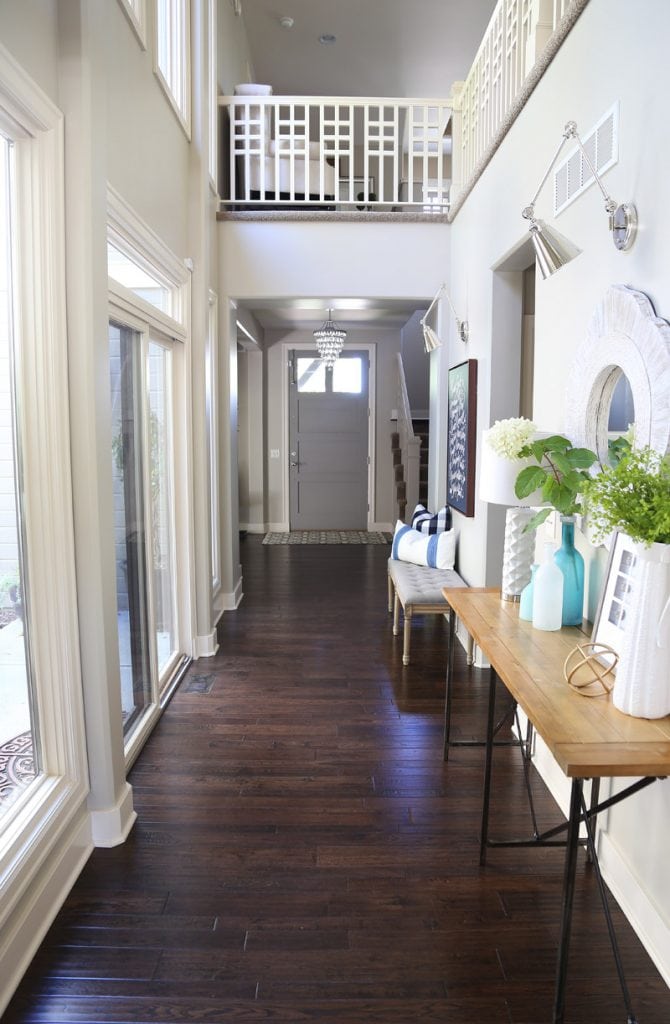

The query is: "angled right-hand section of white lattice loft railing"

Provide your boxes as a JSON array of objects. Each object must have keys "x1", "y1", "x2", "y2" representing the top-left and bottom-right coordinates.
[{"x1": 451, "y1": 0, "x2": 572, "y2": 204}]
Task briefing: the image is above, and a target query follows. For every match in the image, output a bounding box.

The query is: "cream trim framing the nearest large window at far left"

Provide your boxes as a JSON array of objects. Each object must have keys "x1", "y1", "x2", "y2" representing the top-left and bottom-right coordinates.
[{"x1": 0, "y1": 45, "x2": 88, "y2": 937}]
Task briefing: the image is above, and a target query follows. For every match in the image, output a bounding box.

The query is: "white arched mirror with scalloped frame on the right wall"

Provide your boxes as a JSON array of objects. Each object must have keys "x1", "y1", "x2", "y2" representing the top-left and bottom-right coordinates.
[{"x1": 566, "y1": 285, "x2": 670, "y2": 463}]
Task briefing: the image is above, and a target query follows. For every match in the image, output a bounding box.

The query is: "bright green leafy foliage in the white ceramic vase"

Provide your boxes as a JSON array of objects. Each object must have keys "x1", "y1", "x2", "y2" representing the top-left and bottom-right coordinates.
[{"x1": 584, "y1": 447, "x2": 670, "y2": 546}]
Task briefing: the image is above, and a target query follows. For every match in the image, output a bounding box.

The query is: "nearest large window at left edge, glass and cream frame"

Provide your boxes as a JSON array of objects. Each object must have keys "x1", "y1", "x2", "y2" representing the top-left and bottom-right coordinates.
[{"x1": 0, "y1": 45, "x2": 88, "y2": 909}]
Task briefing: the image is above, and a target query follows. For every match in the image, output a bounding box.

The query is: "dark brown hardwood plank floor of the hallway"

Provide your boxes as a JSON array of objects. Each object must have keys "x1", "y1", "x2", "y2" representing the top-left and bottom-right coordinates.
[{"x1": 6, "y1": 537, "x2": 670, "y2": 1024}]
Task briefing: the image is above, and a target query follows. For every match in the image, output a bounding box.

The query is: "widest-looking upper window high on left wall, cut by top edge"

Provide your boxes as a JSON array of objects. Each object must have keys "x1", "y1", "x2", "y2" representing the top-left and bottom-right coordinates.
[{"x1": 156, "y1": 0, "x2": 191, "y2": 136}]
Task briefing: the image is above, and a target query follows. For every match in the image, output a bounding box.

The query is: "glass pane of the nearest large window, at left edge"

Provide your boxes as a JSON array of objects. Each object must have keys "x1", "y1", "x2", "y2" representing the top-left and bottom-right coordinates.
[{"x1": 0, "y1": 136, "x2": 39, "y2": 818}]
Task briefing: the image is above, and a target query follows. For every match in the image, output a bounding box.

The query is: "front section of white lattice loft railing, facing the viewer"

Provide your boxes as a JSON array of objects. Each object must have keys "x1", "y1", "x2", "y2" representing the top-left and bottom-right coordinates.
[{"x1": 219, "y1": 95, "x2": 451, "y2": 213}]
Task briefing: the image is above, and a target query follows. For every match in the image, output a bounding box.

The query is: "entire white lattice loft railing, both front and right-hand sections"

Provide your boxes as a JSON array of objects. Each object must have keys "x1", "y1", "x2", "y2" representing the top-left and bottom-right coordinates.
[{"x1": 219, "y1": 0, "x2": 588, "y2": 221}]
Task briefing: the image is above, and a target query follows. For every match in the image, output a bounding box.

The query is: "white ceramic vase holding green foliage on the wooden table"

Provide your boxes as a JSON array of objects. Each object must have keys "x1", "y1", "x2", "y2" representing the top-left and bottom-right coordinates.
[{"x1": 612, "y1": 544, "x2": 670, "y2": 718}]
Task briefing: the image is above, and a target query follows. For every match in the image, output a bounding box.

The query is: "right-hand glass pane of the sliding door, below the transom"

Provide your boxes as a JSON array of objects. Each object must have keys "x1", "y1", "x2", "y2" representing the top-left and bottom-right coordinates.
[{"x1": 149, "y1": 341, "x2": 177, "y2": 677}]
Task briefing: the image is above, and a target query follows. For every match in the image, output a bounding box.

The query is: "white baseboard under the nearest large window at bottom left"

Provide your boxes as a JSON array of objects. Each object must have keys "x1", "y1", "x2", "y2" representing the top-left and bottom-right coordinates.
[{"x1": 0, "y1": 810, "x2": 93, "y2": 1017}]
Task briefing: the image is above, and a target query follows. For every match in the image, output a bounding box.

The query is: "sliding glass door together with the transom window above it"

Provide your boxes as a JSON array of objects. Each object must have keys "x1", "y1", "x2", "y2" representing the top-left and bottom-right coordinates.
[{"x1": 108, "y1": 189, "x2": 191, "y2": 755}]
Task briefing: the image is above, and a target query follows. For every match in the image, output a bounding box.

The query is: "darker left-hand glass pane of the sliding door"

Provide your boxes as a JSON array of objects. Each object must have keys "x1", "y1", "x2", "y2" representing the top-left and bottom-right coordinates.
[{"x1": 110, "y1": 324, "x2": 152, "y2": 737}]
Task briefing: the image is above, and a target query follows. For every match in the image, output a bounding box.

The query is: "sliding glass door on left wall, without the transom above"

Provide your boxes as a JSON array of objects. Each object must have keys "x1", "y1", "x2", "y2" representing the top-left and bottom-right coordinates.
[{"x1": 109, "y1": 323, "x2": 180, "y2": 740}]
